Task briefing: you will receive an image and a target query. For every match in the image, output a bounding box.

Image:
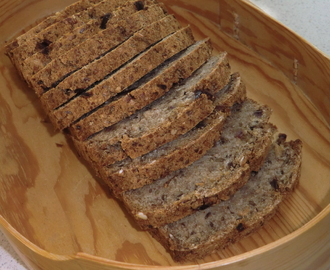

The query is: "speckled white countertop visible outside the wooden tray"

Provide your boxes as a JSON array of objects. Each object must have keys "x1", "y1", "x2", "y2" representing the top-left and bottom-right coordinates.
[{"x1": 0, "y1": 0, "x2": 330, "y2": 270}]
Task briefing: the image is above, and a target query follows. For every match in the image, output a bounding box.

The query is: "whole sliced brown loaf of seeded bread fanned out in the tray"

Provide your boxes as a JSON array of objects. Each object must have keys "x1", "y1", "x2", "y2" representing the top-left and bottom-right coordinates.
[{"x1": 6, "y1": 0, "x2": 302, "y2": 261}]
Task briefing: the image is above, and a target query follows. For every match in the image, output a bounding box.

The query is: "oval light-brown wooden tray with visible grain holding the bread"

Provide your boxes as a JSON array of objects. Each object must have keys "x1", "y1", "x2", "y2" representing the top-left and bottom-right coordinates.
[{"x1": 0, "y1": 0, "x2": 330, "y2": 270}]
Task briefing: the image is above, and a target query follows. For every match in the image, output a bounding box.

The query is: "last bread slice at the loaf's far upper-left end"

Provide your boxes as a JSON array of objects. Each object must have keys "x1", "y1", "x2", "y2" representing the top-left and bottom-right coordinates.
[{"x1": 5, "y1": 0, "x2": 102, "y2": 54}]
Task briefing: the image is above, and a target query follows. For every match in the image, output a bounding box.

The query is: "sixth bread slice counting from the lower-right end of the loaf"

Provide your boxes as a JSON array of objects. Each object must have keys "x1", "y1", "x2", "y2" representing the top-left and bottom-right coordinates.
[{"x1": 49, "y1": 25, "x2": 195, "y2": 130}]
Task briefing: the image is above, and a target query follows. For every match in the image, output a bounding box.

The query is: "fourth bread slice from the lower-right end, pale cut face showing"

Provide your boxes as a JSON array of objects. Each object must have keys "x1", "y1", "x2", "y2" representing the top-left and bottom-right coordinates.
[{"x1": 73, "y1": 52, "x2": 229, "y2": 173}]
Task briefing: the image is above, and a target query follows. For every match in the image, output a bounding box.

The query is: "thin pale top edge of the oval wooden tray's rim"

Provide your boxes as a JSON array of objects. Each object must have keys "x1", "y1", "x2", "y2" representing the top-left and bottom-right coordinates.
[{"x1": 0, "y1": 0, "x2": 330, "y2": 270}]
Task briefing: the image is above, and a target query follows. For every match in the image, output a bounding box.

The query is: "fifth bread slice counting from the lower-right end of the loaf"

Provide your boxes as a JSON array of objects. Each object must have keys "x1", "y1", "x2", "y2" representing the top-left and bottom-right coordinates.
[{"x1": 69, "y1": 40, "x2": 212, "y2": 140}]
